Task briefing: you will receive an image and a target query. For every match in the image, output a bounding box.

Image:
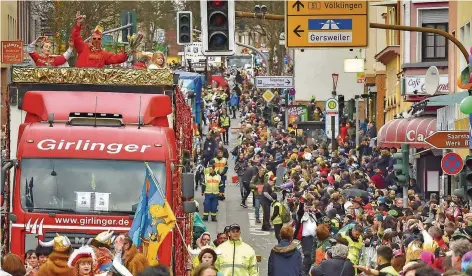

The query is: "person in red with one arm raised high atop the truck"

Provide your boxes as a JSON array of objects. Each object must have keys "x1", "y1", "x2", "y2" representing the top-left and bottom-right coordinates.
[{"x1": 72, "y1": 12, "x2": 128, "y2": 68}]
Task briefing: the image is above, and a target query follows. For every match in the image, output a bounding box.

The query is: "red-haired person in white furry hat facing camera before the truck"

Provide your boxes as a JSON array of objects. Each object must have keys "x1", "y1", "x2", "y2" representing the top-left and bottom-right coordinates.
[{"x1": 67, "y1": 246, "x2": 107, "y2": 276}]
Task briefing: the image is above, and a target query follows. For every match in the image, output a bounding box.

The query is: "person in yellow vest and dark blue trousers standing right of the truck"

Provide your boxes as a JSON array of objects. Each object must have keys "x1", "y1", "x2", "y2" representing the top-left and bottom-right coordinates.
[{"x1": 202, "y1": 160, "x2": 224, "y2": 221}]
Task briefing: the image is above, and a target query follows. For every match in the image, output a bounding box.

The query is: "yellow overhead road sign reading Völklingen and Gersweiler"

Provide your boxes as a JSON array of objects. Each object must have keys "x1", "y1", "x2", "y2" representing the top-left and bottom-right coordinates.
[{"x1": 285, "y1": 1, "x2": 369, "y2": 48}]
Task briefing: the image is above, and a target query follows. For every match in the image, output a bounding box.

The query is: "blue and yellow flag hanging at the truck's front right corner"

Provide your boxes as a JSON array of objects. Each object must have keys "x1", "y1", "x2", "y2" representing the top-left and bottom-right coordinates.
[{"x1": 129, "y1": 163, "x2": 176, "y2": 265}]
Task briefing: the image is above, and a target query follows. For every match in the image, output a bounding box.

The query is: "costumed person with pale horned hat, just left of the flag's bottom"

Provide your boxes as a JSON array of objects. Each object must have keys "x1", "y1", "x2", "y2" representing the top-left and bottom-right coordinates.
[{"x1": 90, "y1": 231, "x2": 113, "y2": 274}]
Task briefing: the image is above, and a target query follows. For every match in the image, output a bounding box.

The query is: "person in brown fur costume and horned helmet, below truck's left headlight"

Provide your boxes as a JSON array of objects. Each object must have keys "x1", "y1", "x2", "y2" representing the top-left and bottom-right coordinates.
[{"x1": 38, "y1": 234, "x2": 73, "y2": 276}]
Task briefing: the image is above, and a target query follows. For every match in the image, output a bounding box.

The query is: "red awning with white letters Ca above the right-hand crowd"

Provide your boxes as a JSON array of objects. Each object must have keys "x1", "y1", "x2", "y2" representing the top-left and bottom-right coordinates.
[{"x1": 377, "y1": 117, "x2": 436, "y2": 148}]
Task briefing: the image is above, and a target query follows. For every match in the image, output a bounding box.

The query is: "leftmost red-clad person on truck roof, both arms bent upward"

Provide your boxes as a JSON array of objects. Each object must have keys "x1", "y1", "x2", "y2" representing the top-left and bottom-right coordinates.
[{"x1": 27, "y1": 36, "x2": 74, "y2": 67}]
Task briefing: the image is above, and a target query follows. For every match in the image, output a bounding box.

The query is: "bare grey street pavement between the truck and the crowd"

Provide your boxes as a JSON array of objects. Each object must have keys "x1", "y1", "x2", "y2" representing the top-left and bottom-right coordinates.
[{"x1": 195, "y1": 118, "x2": 277, "y2": 276}]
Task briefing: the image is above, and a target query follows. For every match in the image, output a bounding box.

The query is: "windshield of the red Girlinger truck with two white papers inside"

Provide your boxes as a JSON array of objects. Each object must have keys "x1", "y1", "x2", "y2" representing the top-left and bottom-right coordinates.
[{"x1": 20, "y1": 158, "x2": 166, "y2": 214}]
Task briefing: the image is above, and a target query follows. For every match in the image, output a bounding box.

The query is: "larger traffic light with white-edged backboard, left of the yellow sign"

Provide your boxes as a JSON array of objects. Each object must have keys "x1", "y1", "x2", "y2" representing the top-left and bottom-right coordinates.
[{"x1": 200, "y1": 0, "x2": 236, "y2": 56}]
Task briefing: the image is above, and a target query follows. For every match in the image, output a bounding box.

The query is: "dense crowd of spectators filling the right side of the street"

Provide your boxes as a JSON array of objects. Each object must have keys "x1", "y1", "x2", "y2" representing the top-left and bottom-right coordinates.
[{"x1": 188, "y1": 67, "x2": 472, "y2": 276}]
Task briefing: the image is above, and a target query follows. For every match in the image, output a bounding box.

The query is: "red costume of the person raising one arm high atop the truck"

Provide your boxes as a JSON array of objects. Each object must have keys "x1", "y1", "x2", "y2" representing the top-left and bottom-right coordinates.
[{"x1": 72, "y1": 25, "x2": 128, "y2": 68}]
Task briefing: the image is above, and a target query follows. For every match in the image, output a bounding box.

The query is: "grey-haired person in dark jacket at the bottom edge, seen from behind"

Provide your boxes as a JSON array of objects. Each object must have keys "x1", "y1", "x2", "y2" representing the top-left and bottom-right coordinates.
[{"x1": 310, "y1": 243, "x2": 355, "y2": 276}]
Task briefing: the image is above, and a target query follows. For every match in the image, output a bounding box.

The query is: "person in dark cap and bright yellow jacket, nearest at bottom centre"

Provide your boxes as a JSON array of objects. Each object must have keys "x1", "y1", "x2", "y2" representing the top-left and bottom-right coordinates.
[{"x1": 215, "y1": 224, "x2": 259, "y2": 276}]
